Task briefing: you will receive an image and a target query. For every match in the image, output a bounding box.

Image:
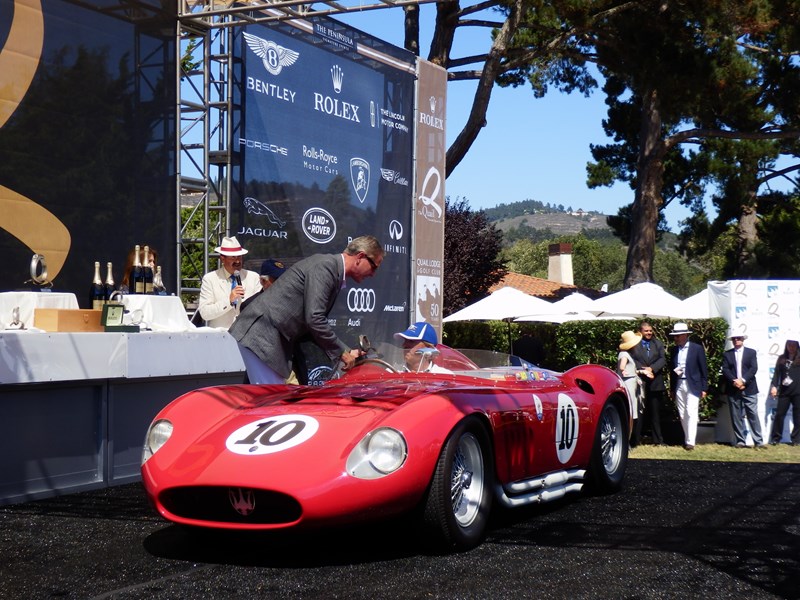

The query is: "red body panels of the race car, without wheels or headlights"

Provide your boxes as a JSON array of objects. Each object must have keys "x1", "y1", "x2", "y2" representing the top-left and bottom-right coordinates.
[{"x1": 142, "y1": 349, "x2": 627, "y2": 529}]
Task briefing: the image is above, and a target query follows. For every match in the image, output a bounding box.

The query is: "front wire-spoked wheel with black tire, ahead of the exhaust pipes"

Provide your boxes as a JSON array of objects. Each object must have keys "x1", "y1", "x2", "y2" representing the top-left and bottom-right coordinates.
[{"x1": 423, "y1": 417, "x2": 494, "y2": 551}]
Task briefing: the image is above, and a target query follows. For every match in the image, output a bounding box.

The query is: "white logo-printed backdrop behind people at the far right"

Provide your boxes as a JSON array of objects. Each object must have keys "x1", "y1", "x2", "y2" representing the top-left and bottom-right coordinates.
[{"x1": 708, "y1": 279, "x2": 800, "y2": 443}]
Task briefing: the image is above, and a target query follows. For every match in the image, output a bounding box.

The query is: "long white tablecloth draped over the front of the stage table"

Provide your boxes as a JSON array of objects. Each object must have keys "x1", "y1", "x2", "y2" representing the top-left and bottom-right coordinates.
[{"x1": 0, "y1": 328, "x2": 244, "y2": 384}]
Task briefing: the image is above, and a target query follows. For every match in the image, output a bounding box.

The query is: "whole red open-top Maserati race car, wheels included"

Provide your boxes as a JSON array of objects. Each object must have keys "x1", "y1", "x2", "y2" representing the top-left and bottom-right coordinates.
[{"x1": 142, "y1": 345, "x2": 630, "y2": 550}]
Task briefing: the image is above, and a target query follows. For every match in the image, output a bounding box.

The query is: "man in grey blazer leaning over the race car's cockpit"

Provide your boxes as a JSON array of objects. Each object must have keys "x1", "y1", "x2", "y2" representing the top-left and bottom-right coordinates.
[{"x1": 229, "y1": 236, "x2": 383, "y2": 383}]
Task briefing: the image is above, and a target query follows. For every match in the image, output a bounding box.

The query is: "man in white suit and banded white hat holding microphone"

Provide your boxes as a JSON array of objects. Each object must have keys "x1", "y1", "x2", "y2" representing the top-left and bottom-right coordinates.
[{"x1": 198, "y1": 237, "x2": 261, "y2": 329}]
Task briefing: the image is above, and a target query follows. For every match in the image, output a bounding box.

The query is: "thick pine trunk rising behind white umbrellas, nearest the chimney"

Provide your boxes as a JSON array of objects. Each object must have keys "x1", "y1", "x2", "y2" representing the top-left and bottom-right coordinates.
[{"x1": 623, "y1": 89, "x2": 667, "y2": 288}]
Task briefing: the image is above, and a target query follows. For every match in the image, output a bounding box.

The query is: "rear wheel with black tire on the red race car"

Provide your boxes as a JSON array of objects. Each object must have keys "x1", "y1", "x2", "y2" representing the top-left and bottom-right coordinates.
[{"x1": 587, "y1": 400, "x2": 628, "y2": 494}]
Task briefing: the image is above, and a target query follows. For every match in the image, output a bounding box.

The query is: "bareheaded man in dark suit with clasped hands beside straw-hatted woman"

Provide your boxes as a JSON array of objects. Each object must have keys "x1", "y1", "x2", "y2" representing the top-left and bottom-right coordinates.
[{"x1": 630, "y1": 321, "x2": 667, "y2": 448}]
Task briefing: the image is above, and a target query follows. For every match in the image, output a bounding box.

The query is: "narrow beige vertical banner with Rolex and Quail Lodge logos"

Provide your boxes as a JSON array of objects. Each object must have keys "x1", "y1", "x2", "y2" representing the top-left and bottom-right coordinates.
[{"x1": 413, "y1": 60, "x2": 447, "y2": 339}]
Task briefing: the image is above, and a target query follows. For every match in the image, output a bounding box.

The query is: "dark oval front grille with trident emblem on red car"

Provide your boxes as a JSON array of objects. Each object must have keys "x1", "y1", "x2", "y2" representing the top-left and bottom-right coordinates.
[{"x1": 160, "y1": 486, "x2": 302, "y2": 525}]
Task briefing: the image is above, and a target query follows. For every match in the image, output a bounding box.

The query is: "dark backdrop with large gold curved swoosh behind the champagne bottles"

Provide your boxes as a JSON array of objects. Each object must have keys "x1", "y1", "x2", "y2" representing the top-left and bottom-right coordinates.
[{"x1": 0, "y1": 0, "x2": 178, "y2": 300}]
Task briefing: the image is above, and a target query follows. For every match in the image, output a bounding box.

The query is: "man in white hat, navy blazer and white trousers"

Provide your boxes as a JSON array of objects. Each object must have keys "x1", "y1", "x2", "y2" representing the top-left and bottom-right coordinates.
[{"x1": 669, "y1": 322, "x2": 708, "y2": 450}]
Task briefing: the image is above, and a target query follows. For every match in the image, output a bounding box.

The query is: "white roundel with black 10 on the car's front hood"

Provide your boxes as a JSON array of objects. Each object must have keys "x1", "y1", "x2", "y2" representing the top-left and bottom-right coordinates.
[{"x1": 225, "y1": 415, "x2": 319, "y2": 456}]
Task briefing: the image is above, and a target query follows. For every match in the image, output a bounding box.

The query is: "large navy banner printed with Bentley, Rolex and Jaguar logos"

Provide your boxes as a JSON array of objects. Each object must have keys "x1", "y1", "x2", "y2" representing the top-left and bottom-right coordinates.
[{"x1": 230, "y1": 19, "x2": 415, "y2": 372}]
